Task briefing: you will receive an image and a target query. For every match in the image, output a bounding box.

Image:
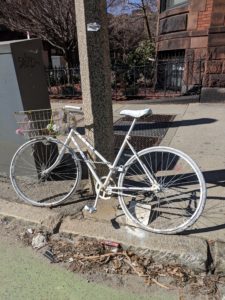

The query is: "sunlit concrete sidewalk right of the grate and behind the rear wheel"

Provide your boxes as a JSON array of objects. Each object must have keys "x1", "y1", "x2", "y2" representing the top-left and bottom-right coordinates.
[{"x1": 115, "y1": 103, "x2": 225, "y2": 242}]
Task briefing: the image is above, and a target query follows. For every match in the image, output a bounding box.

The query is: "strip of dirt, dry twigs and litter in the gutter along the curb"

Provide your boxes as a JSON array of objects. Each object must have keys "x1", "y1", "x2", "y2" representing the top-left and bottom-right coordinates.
[{"x1": 0, "y1": 218, "x2": 225, "y2": 299}]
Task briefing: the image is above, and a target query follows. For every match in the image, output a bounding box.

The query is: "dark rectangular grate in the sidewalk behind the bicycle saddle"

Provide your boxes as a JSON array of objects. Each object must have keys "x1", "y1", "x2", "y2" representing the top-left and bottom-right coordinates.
[{"x1": 113, "y1": 115, "x2": 175, "y2": 151}]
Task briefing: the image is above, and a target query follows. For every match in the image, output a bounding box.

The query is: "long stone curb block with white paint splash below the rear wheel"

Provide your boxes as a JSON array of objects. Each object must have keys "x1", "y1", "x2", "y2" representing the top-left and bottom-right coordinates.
[{"x1": 60, "y1": 217, "x2": 207, "y2": 272}]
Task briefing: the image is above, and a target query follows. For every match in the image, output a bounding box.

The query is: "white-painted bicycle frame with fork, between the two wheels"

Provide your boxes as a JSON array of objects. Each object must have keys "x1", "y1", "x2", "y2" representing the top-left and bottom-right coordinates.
[{"x1": 42, "y1": 113, "x2": 159, "y2": 208}]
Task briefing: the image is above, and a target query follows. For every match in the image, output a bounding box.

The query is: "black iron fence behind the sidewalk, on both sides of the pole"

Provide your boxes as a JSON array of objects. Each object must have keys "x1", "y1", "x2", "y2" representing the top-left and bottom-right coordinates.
[{"x1": 46, "y1": 59, "x2": 209, "y2": 100}]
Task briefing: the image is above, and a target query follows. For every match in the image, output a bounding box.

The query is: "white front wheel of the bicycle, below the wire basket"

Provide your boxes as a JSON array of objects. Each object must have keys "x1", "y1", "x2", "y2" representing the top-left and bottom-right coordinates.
[{"x1": 10, "y1": 137, "x2": 81, "y2": 206}]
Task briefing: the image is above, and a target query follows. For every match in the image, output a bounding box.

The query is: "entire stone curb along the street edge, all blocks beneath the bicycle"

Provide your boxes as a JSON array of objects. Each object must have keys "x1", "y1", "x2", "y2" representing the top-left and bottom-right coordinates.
[{"x1": 0, "y1": 200, "x2": 225, "y2": 274}]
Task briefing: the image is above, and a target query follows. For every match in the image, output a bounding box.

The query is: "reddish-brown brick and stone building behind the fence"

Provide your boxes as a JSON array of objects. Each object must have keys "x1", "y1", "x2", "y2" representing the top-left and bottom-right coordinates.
[{"x1": 157, "y1": 0, "x2": 225, "y2": 101}]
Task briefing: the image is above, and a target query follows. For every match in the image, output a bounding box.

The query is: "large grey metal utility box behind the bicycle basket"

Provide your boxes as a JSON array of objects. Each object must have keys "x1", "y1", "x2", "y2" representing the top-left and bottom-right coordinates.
[{"x1": 0, "y1": 39, "x2": 50, "y2": 175}]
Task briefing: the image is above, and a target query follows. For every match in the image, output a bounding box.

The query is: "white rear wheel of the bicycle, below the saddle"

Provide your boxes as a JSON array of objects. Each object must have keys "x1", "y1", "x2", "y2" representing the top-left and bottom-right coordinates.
[{"x1": 118, "y1": 147, "x2": 206, "y2": 234}]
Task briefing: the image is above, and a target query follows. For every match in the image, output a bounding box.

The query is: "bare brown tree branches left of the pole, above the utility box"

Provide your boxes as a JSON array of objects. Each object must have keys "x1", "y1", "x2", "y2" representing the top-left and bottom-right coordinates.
[{"x1": 0, "y1": 0, "x2": 77, "y2": 66}]
